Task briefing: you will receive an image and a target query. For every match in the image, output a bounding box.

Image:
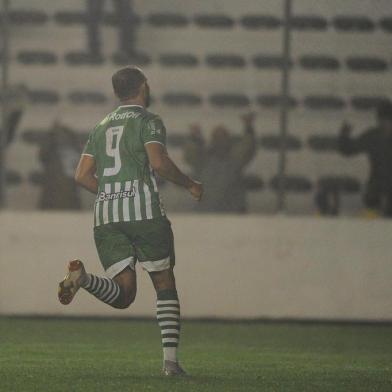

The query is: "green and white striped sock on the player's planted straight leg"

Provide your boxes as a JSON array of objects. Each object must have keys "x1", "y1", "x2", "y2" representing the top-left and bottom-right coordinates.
[{"x1": 157, "y1": 290, "x2": 180, "y2": 362}]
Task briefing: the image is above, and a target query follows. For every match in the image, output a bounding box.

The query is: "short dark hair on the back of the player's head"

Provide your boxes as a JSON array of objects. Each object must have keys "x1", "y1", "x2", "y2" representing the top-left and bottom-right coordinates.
[{"x1": 112, "y1": 66, "x2": 147, "y2": 100}]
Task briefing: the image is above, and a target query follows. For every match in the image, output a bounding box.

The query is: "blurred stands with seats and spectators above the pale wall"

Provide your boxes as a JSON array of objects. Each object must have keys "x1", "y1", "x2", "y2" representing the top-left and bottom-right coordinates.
[{"x1": 1, "y1": 0, "x2": 392, "y2": 217}]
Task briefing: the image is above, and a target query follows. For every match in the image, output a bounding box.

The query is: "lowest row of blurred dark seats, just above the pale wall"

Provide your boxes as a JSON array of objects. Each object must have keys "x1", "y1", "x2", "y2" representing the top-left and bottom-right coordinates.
[{"x1": 6, "y1": 170, "x2": 361, "y2": 194}]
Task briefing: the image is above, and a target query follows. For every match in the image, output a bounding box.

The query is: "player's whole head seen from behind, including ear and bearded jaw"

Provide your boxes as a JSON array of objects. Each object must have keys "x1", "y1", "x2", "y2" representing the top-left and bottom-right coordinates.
[{"x1": 112, "y1": 66, "x2": 150, "y2": 107}]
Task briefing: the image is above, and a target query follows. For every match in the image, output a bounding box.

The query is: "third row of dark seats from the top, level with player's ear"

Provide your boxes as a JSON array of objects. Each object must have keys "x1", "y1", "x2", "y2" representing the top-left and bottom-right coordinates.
[{"x1": 28, "y1": 90, "x2": 388, "y2": 111}]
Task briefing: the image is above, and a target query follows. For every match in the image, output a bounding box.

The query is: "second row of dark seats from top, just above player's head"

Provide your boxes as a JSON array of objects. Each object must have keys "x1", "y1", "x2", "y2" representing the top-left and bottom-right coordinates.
[{"x1": 12, "y1": 50, "x2": 392, "y2": 72}]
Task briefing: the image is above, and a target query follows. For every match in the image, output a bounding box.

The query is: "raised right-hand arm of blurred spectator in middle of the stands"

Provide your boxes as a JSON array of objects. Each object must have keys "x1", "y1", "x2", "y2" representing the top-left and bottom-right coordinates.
[{"x1": 231, "y1": 113, "x2": 256, "y2": 167}]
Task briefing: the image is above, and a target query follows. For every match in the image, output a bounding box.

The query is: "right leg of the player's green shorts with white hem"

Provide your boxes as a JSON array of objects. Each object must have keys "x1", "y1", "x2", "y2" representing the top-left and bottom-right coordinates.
[{"x1": 133, "y1": 218, "x2": 175, "y2": 272}]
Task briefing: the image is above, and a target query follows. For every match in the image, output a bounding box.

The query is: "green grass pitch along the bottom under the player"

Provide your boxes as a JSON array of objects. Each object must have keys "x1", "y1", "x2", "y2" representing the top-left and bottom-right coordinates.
[{"x1": 0, "y1": 318, "x2": 392, "y2": 392}]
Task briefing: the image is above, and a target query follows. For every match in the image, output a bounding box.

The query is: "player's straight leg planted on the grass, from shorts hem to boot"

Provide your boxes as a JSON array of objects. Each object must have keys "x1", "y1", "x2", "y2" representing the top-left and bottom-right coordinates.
[{"x1": 150, "y1": 268, "x2": 186, "y2": 376}]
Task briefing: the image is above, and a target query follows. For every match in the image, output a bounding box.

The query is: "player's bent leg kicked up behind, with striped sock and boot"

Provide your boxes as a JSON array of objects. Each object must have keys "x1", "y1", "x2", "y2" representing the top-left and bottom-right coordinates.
[{"x1": 58, "y1": 260, "x2": 136, "y2": 309}]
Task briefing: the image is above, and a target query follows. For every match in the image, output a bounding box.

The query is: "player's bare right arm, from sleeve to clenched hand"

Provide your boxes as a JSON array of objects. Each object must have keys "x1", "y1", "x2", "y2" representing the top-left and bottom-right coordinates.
[{"x1": 145, "y1": 142, "x2": 203, "y2": 201}]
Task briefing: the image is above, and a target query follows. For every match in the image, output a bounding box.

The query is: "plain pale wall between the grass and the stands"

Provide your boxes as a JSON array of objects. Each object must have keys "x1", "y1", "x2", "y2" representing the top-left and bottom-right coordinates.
[{"x1": 0, "y1": 212, "x2": 392, "y2": 320}]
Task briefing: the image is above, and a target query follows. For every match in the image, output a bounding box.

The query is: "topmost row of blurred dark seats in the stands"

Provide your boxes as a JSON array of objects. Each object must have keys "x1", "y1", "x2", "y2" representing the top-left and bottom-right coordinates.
[{"x1": 0, "y1": 10, "x2": 392, "y2": 33}]
